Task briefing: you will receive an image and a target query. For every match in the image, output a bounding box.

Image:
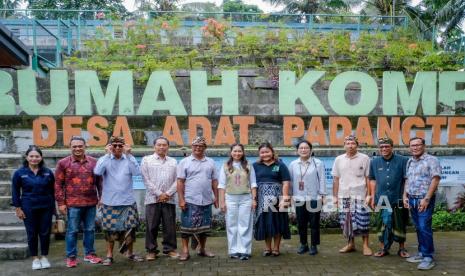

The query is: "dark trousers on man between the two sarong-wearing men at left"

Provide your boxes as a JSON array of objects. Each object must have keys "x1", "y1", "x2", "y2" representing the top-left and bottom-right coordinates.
[{"x1": 145, "y1": 203, "x2": 177, "y2": 253}]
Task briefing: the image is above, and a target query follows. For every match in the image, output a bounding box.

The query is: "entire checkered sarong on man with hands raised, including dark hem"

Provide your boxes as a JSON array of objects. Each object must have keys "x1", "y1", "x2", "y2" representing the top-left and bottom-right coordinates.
[{"x1": 102, "y1": 203, "x2": 139, "y2": 241}]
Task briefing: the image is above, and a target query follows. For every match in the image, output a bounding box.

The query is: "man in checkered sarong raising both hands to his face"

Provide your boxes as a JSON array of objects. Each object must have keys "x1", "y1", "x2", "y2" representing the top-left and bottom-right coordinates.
[{"x1": 94, "y1": 136, "x2": 144, "y2": 265}]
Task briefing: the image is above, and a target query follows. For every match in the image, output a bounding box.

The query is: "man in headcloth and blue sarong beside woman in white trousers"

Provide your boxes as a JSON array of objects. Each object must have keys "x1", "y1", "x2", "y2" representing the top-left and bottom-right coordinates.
[{"x1": 177, "y1": 137, "x2": 218, "y2": 261}]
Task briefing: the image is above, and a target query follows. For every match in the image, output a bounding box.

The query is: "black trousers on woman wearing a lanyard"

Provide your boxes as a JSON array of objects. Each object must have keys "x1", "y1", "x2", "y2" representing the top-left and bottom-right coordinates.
[{"x1": 295, "y1": 200, "x2": 321, "y2": 245}]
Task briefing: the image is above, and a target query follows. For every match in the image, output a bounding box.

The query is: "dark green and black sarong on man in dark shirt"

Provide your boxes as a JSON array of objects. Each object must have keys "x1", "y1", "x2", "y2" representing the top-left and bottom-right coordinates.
[{"x1": 376, "y1": 205, "x2": 408, "y2": 250}]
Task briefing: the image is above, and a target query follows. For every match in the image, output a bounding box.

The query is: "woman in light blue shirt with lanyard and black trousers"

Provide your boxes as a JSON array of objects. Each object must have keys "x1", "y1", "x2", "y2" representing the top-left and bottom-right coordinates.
[{"x1": 289, "y1": 140, "x2": 326, "y2": 255}]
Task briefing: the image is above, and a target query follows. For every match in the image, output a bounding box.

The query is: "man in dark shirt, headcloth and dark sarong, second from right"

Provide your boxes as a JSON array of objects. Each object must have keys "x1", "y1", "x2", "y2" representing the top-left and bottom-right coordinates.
[{"x1": 368, "y1": 137, "x2": 409, "y2": 258}]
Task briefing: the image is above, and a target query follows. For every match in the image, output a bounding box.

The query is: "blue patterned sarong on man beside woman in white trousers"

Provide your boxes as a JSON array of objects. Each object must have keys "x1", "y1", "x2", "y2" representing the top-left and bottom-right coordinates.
[{"x1": 180, "y1": 203, "x2": 212, "y2": 237}]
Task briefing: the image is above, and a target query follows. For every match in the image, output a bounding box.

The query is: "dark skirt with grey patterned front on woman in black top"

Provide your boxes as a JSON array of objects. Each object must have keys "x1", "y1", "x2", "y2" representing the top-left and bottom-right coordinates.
[{"x1": 254, "y1": 182, "x2": 291, "y2": 241}]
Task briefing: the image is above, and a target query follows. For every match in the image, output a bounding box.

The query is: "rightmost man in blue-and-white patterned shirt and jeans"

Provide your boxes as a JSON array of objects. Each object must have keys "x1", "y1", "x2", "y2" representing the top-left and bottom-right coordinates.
[{"x1": 403, "y1": 137, "x2": 441, "y2": 270}]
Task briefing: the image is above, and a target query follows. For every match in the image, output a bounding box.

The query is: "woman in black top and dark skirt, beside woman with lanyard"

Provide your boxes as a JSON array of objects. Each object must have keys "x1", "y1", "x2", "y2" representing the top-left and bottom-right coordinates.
[{"x1": 253, "y1": 143, "x2": 291, "y2": 256}]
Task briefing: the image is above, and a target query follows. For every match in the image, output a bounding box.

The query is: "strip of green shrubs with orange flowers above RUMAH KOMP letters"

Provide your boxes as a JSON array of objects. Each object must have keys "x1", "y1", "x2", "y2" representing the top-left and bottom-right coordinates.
[{"x1": 65, "y1": 17, "x2": 463, "y2": 82}]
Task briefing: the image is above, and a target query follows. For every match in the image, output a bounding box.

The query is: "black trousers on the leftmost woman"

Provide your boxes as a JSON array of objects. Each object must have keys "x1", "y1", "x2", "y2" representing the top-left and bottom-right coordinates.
[{"x1": 23, "y1": 208, "x2": 54, "y2": 256}]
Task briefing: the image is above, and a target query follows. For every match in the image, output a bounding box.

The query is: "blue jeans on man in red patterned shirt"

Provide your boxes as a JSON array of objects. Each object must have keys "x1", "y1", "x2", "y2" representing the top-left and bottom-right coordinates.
[{"x1": 66, "y1": 206, "x2": 96, "y2": 258}]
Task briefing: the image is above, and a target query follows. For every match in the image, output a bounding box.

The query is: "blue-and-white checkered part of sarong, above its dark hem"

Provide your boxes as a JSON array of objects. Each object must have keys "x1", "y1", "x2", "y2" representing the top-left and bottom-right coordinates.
[{"x1": 102, "y1": 203, "x2": 139, "y2": 232}]
